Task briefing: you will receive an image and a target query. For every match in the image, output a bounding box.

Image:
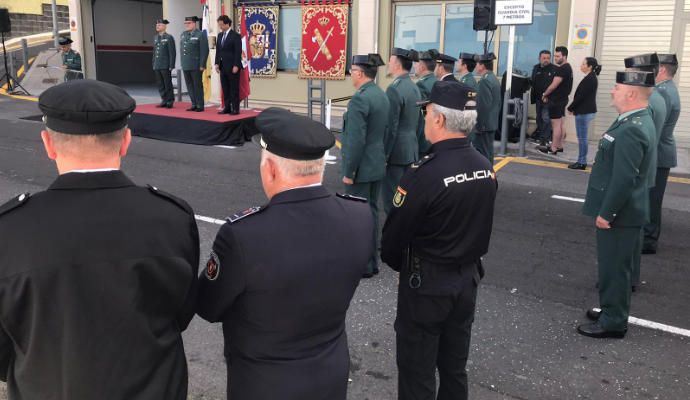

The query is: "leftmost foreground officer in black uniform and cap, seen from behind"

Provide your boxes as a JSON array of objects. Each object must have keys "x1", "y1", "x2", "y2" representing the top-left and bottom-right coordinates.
[{"x1": 0, "y1": 80, "x2": 199, "y2": 400}]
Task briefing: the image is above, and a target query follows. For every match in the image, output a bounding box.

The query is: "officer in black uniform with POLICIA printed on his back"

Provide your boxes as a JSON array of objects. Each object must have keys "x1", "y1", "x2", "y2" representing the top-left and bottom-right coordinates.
[{"x1": 381, "y1": 82, "x2": 497, "y2": 400}]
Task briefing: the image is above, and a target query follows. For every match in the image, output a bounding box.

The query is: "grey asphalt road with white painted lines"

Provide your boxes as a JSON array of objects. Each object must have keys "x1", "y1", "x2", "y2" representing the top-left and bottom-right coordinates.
[{"x1": 0, "y1": 97, "x2": 690, "y2": 400}]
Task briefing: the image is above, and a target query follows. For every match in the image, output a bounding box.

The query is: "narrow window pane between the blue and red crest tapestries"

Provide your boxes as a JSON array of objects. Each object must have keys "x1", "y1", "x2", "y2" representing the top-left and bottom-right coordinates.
[{"x1": 278, "y1": 7, "x2": 302, "y2": 71}]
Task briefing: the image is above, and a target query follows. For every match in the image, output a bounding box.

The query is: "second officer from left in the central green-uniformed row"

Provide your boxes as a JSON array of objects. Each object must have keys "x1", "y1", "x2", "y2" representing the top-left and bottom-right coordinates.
[{"x1": 382, "y1": 47, "x2": 420, "y2": 214}]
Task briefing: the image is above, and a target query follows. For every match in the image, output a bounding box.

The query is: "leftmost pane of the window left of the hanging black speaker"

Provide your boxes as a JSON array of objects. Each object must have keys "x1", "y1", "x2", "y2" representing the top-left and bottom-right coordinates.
[{"x1": 393, "y1": 4, "x2": 441, "y2": 51}]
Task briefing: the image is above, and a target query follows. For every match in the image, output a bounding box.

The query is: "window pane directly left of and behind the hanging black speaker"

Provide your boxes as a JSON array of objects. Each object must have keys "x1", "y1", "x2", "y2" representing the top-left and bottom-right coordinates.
[{"x1": 443, "y1": 3, "x2": 493, "y2": 58}]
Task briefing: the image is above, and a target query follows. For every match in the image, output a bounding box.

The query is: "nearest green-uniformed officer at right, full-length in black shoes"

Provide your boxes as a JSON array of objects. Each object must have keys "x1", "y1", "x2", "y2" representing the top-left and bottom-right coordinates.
[{"x1": 578, "y1": 71, "x2": 655, "y2": 338}]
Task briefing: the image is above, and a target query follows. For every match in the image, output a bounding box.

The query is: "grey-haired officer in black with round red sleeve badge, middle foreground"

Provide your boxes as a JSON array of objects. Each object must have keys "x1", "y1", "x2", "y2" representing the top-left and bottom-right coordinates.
[{"x1": 197, "y1": 108, "x2": 374, "y2": 400}]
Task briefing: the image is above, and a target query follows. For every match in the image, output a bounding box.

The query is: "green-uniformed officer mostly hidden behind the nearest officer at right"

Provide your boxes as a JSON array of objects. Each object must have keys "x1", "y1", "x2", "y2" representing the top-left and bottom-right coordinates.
[{"x1": 624, "y1": 53, "x2": 666, "y2": 292}]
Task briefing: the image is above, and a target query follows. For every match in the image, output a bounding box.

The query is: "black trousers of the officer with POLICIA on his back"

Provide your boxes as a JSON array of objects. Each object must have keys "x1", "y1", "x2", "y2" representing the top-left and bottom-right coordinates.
[{"x1": 395, "y1": 264, "x2": 480, "y2": 400}]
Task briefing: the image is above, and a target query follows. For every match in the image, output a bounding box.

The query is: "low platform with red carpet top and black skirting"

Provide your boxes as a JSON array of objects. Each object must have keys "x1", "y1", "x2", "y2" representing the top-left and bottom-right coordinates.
[{"x1": 128, "y1": 103, "x2": 261, "y2": 146}]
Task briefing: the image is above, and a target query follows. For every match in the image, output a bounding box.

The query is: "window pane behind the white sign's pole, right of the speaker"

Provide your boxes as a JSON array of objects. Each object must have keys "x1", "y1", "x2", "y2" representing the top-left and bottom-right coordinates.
[{"x1": 498, "y1": 0, "x2": 558, "y2": 76}]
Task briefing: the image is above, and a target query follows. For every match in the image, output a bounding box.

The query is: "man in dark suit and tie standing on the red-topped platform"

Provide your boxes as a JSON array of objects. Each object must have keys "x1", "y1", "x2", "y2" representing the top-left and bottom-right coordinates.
[{"x1": 215, "y1": 15, "x2": 242, "y2": 115}]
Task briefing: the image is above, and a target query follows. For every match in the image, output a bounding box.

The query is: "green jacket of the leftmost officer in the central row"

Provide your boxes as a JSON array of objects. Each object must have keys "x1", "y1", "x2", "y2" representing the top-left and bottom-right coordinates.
[{"x1": 341, "y1": 82, "x2": 389, "y2": 183}]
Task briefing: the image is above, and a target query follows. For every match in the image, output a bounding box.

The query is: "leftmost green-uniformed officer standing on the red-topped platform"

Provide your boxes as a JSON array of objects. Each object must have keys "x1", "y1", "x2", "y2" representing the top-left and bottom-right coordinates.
[{"x1": 153, "y1": 18, "x2": 177, "y2": 108}]
